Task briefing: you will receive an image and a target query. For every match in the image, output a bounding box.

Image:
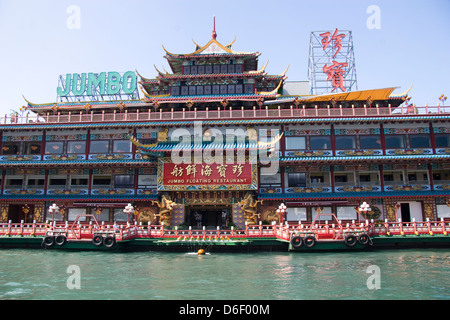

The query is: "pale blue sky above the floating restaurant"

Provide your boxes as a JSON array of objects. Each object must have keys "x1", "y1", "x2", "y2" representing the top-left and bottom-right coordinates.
[{"x1": 0, "y1": 0, "x2": 450, "y2": 114}]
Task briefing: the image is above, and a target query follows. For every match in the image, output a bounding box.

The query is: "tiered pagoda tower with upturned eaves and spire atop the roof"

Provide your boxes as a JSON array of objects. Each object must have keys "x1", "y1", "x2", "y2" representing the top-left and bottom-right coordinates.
[{"x1": 139, "y1": 18, "x2": 287, "y2": 110}]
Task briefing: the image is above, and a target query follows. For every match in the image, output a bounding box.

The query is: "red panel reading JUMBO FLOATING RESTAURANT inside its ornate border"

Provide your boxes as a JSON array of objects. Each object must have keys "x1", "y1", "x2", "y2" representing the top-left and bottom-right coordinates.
[{"x1": 162, "y1": 162, "x2": 253, "y2": 186}]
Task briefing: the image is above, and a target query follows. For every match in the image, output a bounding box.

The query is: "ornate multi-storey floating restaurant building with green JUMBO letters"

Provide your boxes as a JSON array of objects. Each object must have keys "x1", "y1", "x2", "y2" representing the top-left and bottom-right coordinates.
[{"x1": 0, "y1": 24, "x2": 450, "y2": 238}]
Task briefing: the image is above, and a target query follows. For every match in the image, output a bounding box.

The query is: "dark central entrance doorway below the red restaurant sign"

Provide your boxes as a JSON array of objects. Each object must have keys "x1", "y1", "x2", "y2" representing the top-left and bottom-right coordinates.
[{"x1": 187, "y1": 207, "x2": 230, "y2": 229}]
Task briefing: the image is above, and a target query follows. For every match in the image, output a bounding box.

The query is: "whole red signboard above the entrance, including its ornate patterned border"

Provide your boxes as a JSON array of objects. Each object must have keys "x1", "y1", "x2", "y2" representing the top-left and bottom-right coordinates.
[{"x1": 158, "y1": 159, "x2": 258, "y2": 190}]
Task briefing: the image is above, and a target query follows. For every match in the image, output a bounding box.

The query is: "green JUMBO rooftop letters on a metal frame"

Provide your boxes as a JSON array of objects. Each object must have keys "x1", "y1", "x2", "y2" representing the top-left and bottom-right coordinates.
[{"x1": 56, "y1": 71, "x2": 137, "y2": 97}]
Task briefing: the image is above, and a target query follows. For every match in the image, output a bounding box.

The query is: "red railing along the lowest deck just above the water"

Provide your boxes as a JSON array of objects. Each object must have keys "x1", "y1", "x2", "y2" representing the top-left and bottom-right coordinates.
[{"x1": 0, "y1": 219, "x2": 450, "y2": 241}]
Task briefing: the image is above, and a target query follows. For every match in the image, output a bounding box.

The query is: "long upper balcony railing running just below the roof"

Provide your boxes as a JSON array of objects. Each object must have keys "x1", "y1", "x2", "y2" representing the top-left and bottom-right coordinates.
[{"x1": 0, "y1": 103, "x2": 450, "y2": 125}]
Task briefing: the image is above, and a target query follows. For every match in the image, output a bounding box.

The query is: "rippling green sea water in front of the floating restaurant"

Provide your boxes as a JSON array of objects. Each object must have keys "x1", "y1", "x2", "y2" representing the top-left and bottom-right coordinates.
[{"x1": 0, "y1": 249, "x2": 450, "y2": 300}]
